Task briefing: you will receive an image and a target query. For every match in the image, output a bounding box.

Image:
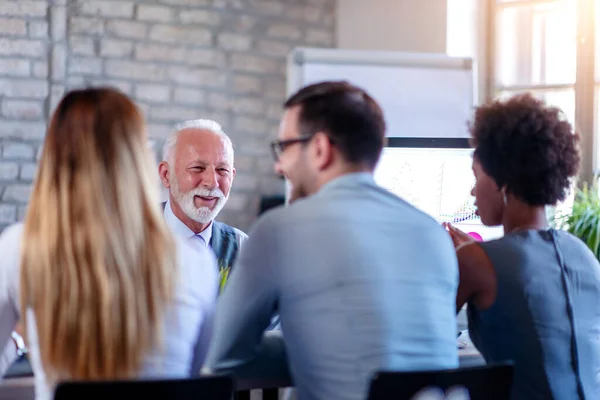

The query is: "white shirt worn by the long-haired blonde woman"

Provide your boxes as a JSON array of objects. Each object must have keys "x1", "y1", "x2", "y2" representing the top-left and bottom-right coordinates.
[{"x1": 0, "y1": 224, "x2": 218, "y2": 400}]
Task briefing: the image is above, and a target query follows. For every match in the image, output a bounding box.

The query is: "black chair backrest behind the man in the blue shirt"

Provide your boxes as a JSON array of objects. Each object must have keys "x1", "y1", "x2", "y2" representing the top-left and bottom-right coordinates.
[{"x1": 369, "y1": 364, "x2": 513, "y2": 400}]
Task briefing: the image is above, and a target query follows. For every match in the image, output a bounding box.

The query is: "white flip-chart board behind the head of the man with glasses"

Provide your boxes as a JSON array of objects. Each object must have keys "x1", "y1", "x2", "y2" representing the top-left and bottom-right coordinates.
[{"x1": 287, "y1": 48, "x2": 476, "y2": 143}]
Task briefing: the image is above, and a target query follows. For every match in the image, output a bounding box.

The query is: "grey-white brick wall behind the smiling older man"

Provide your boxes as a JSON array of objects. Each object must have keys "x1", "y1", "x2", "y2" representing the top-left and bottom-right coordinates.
[{"x1": 0, "y1": 0, "x2": 335, "y2": 231}]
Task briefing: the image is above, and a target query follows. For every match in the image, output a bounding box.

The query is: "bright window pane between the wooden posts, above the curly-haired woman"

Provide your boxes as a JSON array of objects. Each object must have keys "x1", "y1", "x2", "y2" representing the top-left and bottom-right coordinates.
[{"x1": 492, "y1": 0, "x2": 577, "y2": 123}]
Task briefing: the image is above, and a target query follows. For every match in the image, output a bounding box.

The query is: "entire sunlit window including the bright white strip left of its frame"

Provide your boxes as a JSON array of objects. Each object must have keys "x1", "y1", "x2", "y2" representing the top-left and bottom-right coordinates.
[{"x1": 447, "y1": 0, "x2": 600, "y2": 212}]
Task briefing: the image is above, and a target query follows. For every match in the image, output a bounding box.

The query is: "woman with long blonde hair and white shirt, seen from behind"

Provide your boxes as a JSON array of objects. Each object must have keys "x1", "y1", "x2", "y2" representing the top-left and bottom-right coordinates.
[{"x1": 0, "y1": 88, "x2": 218, "y2": 400}]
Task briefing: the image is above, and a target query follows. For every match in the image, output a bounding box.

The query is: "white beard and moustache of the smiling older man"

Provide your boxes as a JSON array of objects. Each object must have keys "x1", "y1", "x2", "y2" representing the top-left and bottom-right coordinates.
[{"x1": 171, "y1": 177, "x2": 229, "y2": 224}]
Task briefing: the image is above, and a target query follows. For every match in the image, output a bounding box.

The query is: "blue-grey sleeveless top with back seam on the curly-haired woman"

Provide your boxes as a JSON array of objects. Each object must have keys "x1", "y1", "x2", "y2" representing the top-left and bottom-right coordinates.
[{"x1": 467, "y1": 229, "x2": 600, "y2": 400}]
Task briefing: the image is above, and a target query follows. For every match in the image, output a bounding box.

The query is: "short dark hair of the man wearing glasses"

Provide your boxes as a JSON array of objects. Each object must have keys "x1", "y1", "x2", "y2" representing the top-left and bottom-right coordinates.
[{"x1": 284, "y1": 81, "x2": 385, "y2": 168}]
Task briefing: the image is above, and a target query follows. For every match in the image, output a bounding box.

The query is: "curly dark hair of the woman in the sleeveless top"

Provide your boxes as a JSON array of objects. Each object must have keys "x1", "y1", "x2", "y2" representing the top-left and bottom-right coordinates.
[{"x1": 469, "y1": 94, "x2": 581, "y2": 206}]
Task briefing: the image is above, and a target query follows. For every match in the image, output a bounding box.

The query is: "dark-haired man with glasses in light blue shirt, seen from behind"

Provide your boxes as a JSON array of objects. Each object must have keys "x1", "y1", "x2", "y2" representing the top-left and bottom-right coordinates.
[{"x1": 205, "y1": 82, "x2": 458, "y2": 400}]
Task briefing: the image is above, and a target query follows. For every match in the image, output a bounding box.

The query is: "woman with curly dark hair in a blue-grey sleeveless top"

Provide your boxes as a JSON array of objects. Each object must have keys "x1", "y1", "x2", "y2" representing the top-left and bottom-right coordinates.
[{"x1": 446, "y1": 94, "x2": 600, "y2": 400}]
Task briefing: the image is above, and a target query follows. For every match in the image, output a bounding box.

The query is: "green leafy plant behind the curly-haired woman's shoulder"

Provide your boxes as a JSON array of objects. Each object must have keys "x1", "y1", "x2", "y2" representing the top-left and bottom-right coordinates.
[{"x1": 551, "y1": 180, "x2": 600, "y2": 260}]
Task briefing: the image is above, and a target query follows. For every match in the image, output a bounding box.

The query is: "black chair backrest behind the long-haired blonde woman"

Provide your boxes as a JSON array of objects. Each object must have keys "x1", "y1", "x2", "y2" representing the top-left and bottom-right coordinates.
[{"x1": 54, "y1": 376, "x2": 233, "y2": 400}]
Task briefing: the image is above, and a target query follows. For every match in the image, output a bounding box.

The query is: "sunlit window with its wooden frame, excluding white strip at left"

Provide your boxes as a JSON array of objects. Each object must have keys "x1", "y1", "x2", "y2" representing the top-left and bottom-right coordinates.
[{"x1": 487, "y1": 0, "x2": 600, "y2": 211}]
